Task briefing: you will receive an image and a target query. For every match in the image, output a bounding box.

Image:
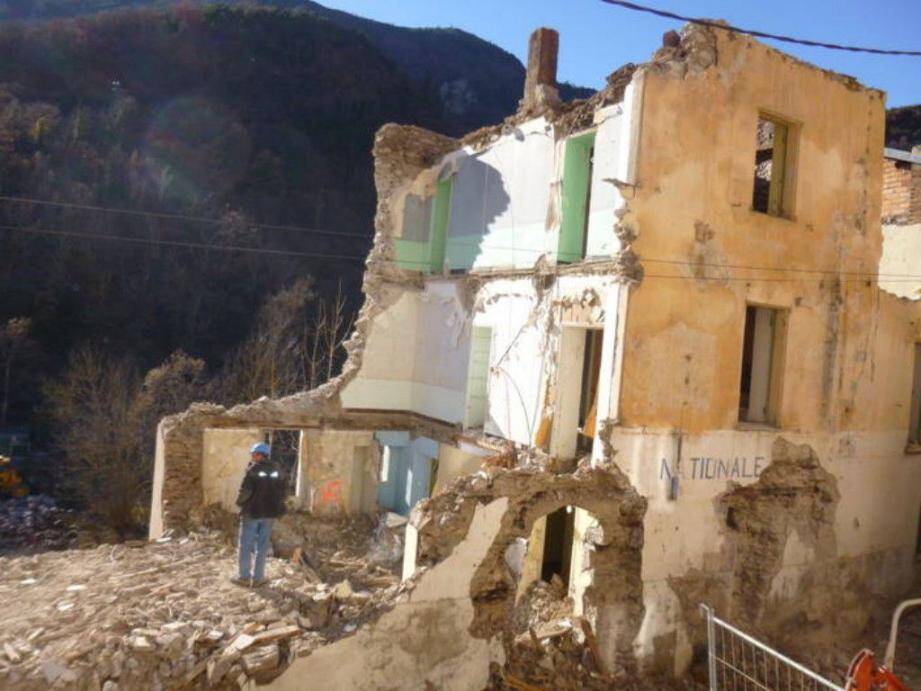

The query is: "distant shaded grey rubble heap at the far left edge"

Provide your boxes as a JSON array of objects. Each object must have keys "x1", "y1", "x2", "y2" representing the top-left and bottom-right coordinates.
[{"x1": 0, "y1": 494, "x2": 77, "y2": 553}]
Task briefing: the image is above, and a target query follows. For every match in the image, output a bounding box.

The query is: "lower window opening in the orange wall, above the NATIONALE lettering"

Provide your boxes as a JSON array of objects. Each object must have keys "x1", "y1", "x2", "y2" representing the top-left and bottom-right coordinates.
[{"x1": 739, "y1": 305, "x2": 786, "y2": 424}]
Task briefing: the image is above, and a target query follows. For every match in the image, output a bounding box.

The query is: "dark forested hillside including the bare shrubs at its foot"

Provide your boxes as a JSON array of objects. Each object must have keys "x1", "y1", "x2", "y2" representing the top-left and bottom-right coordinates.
[{"x1": 0, "y1": 0, "x2": 586, "y2": 533}]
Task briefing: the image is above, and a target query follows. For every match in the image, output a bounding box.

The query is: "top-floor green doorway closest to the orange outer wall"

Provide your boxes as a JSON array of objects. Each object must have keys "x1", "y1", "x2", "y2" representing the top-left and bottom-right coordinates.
[{"x1": 557, "y1": 132, "x2": 595, "y2": 263}]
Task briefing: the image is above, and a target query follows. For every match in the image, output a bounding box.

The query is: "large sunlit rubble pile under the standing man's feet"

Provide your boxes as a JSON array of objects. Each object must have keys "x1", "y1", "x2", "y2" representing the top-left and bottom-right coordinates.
[{"x1": 0, "y1": 517, "x2": 402, "y2": 691}]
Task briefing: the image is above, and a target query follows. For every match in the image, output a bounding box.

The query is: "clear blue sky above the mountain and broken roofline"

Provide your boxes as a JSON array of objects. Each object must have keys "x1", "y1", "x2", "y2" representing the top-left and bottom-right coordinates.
[{"x1": 319, "y1": 0, "x2": 921, "y2": 107}]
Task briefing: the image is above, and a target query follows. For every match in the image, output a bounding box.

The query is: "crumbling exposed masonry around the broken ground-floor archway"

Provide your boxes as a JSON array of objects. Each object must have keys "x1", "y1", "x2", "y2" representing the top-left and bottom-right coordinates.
[{"x1": 402, "y1": 457, "x2": 646, "y2": 671}]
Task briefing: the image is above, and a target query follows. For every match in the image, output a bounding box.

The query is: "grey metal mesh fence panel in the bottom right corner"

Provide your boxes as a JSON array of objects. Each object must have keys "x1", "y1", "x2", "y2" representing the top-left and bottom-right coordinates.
[{"x1": 700, "y1": 605, "x2": 845, "y2": 691}]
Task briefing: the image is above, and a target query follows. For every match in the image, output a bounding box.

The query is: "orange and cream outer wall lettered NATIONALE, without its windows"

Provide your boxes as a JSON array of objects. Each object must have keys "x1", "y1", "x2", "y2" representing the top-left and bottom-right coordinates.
[{"x1": 604, "y1": 28, "x2": 921, "y2": 673}]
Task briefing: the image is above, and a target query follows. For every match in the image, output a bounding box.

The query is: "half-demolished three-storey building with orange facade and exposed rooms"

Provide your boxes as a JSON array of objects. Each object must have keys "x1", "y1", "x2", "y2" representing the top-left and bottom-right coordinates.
[{"x1": 150, "y1": 20, "x2": 921, "y2": 689}]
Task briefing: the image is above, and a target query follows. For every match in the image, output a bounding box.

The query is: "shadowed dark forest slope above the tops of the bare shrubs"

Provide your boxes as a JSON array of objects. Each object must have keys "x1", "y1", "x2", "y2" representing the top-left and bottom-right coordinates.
[{"x1": 0, "y1": 7, "x2": 448, "y2": 444}]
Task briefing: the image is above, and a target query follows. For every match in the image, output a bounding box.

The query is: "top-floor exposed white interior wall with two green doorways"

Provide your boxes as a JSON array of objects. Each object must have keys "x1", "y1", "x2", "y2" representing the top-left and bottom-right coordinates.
[{"x1": 396, "y1": 93, "x2": 632, "y2": 274}]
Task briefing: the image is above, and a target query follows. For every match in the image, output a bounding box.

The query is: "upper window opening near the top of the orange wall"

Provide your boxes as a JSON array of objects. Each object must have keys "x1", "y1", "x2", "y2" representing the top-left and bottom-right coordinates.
[{"x1": 752, "y1": 115, "x2": 791, "y2": 216}]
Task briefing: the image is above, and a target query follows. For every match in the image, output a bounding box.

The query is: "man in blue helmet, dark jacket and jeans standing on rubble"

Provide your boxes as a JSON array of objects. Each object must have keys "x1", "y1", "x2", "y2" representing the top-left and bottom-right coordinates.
[{"x1": 233, "y1": 442, "x2": 285, "y2": 587}]
